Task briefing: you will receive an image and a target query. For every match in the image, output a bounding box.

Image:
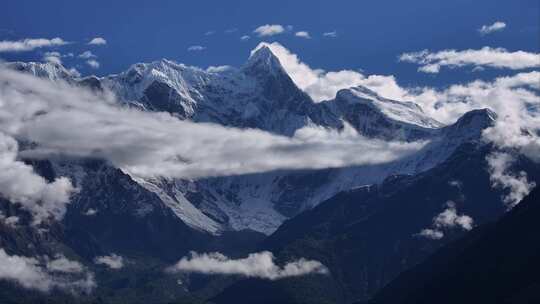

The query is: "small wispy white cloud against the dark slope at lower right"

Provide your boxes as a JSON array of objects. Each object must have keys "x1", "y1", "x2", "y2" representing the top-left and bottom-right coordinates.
[{"x1": 416, "y1": 201, "x2": 474, "y2": 240}]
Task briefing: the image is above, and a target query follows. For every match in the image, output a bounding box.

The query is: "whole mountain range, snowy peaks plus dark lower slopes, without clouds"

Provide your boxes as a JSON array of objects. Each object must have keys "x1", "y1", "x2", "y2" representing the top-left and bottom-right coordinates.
[{"x1": 0, "y1": 47, "x2": 540, "y2": 304}]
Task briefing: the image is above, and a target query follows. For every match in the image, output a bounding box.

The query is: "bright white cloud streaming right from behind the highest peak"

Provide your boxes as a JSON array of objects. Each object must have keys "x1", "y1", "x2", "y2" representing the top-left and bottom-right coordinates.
[{"x1": 251, "y1": 42, "x2": 407, "y2": 102}]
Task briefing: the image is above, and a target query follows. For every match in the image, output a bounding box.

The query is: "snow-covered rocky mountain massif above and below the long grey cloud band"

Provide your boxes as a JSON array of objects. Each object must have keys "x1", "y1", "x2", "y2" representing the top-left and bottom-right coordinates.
[{"x1": 3, "y1": 47, "x2": 495, "y2": 234}]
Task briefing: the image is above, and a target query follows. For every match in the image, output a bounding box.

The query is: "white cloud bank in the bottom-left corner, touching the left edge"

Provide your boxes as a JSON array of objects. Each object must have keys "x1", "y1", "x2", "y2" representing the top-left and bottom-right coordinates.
[{"x1": 0, "y1": 248, "x2": 96, "y2": 293}]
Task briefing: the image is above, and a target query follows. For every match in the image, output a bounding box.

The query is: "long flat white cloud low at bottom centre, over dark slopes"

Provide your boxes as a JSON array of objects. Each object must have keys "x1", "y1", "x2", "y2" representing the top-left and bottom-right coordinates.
[{"x1": 167, "y1": 251, "x2": 329, "y2": 280}]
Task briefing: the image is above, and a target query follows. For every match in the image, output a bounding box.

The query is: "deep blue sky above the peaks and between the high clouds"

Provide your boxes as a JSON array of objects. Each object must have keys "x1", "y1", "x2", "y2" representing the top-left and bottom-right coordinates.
[{"x1": 0, "y1": 0, "x2": 540, "y2": 85}]
